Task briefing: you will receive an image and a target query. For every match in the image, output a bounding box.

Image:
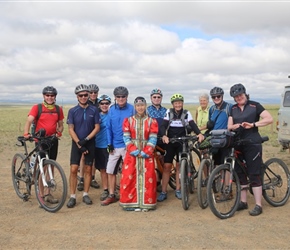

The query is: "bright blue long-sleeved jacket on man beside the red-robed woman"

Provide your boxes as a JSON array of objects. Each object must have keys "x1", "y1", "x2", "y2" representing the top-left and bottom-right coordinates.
[{"x1": 106, "y1": 103, "x2": 135, "y2": 148}]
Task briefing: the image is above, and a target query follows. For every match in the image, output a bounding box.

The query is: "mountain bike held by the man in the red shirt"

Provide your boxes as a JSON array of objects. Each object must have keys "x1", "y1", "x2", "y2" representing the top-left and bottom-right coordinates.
[{"x1": 11, "y1": 132, "x2": 67, "y2": 213}]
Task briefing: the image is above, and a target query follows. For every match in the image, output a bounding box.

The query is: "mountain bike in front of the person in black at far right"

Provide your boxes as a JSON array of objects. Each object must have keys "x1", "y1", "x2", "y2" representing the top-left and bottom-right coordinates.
[{"x1": 207, "y1": 130, "x2": 290, "y2": 219}]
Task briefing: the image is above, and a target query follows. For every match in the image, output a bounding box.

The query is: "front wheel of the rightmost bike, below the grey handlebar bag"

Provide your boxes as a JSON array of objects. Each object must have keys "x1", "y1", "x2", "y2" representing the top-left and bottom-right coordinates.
[{"x1": 207, "y1": 164, "x2": 241, "y2": 219}]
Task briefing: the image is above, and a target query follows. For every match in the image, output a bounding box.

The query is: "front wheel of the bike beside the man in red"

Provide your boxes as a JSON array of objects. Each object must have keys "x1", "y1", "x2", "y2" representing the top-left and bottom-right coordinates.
[{"x1": 34, "y1": 159, "x2": 67, "y2": 213}]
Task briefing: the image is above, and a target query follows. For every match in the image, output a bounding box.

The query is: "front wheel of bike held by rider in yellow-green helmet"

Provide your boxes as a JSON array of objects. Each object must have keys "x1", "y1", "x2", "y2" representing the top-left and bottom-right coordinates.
[{"x1": 180, "y1": 159, "x2": 189, "y2": 210}]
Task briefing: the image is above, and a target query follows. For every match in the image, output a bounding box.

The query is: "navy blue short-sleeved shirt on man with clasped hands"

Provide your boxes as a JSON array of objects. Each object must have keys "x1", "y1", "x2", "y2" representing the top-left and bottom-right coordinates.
[{"x1": 66, "y1": 105, "x2": 100, "y2": 140}]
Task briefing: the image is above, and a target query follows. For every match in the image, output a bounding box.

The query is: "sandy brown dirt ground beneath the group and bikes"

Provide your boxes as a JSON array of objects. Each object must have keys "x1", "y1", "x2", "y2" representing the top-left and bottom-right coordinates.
[{"x1": 0, "y1": 139, "x2": 290, "y2": 249}]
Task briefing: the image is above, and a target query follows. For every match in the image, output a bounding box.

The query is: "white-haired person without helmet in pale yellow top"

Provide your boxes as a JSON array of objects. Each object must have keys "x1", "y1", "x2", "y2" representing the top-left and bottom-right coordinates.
[{"x1": 195, "y1": 93, "x2": 209, "y2": 134}]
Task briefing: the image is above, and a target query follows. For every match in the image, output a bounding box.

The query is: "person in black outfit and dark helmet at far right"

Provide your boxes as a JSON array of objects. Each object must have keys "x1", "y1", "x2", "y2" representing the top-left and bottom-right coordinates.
[{"x1": 228, "y1": 83, "x2": 273, "y2": 216}]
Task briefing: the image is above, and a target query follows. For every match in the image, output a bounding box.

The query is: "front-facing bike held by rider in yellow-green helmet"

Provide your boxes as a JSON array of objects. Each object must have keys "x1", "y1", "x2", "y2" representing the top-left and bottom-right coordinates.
[{"x1": 169, "y1": 135, "x2": 201, "y2": 210}]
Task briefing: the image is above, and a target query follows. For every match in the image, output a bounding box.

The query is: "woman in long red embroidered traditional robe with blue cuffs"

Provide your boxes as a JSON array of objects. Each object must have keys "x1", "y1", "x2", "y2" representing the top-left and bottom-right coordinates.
[{"x1": 120, "y1": 96, "x2": 158, "y2": 211}]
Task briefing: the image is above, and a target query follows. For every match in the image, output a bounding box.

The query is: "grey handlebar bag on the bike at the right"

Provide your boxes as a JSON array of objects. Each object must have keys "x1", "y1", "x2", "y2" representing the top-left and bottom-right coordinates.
[{"x1": 210, "y1": 129, "x2": 234, "y2": 148}]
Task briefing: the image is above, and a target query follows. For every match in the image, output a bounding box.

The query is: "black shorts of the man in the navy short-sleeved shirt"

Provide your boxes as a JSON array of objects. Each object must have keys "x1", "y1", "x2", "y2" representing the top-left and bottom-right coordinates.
[{"x1": 70, "y1": 140, "x2": 95, "y2": 166}]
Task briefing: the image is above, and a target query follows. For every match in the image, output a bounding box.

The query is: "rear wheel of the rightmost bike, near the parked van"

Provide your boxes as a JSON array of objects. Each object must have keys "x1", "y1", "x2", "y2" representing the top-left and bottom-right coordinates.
[{"x1": 263, "y1": 158, "x2": 290, "y2": 207}]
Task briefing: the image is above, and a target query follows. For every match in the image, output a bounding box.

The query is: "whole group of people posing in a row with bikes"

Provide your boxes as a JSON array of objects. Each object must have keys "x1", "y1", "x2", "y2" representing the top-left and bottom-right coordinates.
[{"x1": 24, "y1": 83, "x2": 273, "y2": 216}]
